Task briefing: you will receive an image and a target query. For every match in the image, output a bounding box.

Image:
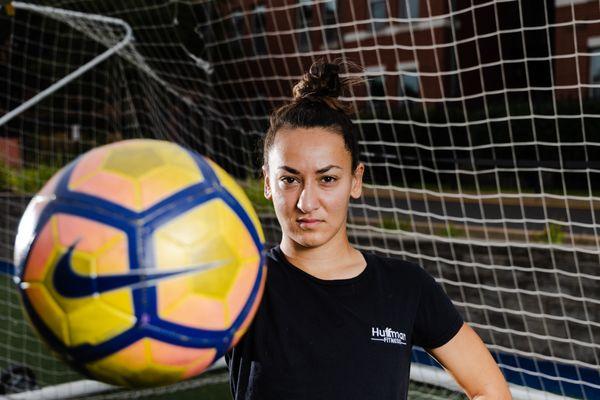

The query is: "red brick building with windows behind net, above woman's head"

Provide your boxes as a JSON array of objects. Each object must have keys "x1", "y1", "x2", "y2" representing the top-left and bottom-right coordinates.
[{"x1": 213, "y1": 0, "x2": 451, "y2": 114}]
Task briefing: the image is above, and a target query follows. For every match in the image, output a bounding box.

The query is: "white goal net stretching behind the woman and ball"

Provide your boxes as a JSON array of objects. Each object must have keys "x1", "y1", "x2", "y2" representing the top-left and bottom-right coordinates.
[{"x1": 0, "y1": 0, "x2": 600, "y2": 399}]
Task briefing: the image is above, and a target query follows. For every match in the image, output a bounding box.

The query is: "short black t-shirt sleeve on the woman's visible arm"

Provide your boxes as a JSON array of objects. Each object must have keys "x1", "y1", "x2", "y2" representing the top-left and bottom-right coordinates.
[{"x1": 412, "y1": 270, "x2": 463, "y2": 349}]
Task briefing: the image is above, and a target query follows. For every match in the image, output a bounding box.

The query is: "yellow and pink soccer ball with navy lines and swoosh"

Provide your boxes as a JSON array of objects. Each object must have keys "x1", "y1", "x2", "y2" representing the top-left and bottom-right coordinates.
[{"x1": 15, "y1": 139, "x2": 266, "y2": 387}]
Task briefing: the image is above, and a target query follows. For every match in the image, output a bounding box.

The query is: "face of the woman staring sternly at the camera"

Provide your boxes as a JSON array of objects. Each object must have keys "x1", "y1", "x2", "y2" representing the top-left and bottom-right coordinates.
[{"x1": 263, "y1": 128, "x2": 364, "y2": 247}]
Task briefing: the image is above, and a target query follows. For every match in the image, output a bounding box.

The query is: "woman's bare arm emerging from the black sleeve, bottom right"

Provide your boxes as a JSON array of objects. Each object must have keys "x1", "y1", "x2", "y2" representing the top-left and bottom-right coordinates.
[{"x1": 428, "y1": 324, "x2": 512, "y2": 400}]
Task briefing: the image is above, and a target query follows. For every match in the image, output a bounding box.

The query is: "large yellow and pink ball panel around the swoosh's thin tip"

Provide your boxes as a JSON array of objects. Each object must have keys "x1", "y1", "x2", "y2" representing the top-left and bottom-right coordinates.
[{"x1": 154, "y1": 194, "x2": 260, "y2": 329}]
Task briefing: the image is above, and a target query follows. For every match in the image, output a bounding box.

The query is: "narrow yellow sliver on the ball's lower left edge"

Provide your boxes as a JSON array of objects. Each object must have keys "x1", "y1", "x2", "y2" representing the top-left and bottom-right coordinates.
[{"x1": 25, "y1": 283, "x2": 71, "y2": 345}]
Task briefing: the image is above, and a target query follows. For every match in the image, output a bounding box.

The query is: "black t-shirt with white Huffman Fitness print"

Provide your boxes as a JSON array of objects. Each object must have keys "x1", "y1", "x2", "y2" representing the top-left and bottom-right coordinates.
[{"x1": 225, "y1": 246, "x2": 462, "y2": 400}]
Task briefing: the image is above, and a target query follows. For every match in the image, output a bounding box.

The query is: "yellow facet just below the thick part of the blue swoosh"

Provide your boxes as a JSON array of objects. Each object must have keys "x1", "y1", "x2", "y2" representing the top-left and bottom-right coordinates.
[{"x1": 67, "y1": 289, "x2": 135, "y2": 346}]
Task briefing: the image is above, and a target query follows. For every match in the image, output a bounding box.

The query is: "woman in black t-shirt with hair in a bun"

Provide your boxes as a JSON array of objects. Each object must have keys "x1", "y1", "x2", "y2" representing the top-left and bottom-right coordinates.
[{"x1": 226, "y1": 61, "x2": 510, "y2": 400}]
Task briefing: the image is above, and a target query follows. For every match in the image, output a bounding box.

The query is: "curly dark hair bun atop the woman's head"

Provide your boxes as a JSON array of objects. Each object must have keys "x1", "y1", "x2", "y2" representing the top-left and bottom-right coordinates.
[{"x1": 293, "y1": 60, "x2": 342, "y2": 100}]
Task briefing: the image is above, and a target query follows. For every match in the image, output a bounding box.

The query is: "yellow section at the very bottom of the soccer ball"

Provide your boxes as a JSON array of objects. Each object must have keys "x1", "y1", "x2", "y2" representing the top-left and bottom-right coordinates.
[{"x1": 87, "y1": 339, "x2": 185, "y2": 387}]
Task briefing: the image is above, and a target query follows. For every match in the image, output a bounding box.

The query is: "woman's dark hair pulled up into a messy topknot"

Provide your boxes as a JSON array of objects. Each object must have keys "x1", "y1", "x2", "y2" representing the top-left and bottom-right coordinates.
[{"x1": 263, "y1": 59, "x2": 364, "y2": 172}]
